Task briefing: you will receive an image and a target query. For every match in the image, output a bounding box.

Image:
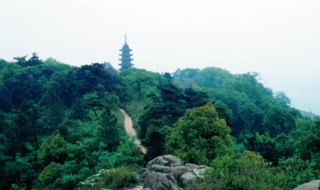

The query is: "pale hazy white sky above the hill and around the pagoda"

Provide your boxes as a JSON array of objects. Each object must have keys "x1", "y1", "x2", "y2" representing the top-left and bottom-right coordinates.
[{"x1": 0, "y1": 0, "x2": 320, "y2": 115}]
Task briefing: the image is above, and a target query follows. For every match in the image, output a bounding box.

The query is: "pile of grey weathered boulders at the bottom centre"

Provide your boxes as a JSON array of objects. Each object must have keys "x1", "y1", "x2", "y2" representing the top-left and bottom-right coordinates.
[{"x1": 141, "y1": 155, "x2": 209, "y2": 190}]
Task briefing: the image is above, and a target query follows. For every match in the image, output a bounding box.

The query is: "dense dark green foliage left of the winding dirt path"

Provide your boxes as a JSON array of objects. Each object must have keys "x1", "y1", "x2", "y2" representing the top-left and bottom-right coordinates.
[{"x1": 0, "y1": 57, "x2": 142, "y2": 189}]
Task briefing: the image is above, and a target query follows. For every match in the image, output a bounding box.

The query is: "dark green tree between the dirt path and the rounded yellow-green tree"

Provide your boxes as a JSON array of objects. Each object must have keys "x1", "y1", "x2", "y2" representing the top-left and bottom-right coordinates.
[{"x1": 139, "y1": 84, "x2": 190, "y2": 161}]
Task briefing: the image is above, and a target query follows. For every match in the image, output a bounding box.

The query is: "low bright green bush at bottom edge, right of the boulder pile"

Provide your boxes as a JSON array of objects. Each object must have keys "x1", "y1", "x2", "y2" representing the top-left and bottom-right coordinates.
[{"x1": 187, "y1": 151, "x2": 287, "y2": 190}]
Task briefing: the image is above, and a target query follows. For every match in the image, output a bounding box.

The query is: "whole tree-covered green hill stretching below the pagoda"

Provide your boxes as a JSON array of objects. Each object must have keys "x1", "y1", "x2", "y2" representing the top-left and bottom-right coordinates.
[{"x1": 0, "y1": 54, "x2": 320, "y2": 189}]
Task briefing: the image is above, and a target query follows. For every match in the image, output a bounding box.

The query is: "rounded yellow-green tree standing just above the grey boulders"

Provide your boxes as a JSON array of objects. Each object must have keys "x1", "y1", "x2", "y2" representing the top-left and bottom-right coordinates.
[{"x1": 166, "y1": 103, "x2": 232, "y2": 164}]
